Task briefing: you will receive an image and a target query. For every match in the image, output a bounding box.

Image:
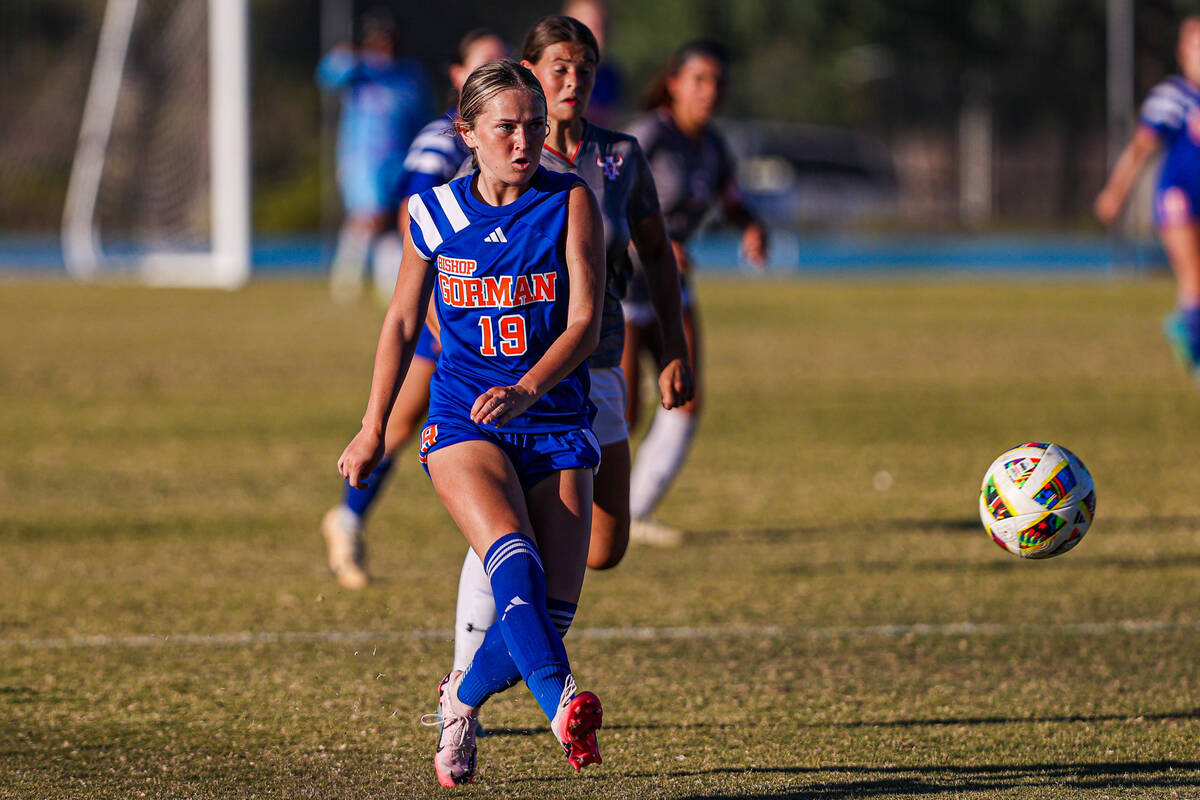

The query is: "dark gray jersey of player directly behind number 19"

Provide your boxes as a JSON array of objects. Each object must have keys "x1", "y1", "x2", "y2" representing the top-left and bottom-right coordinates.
[{"x1": 541, "y1": 124, "x2": 659, "y2": 367}]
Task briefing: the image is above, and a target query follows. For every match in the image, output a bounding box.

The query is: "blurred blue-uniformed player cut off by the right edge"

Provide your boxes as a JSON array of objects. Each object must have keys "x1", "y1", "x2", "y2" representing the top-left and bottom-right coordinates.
[{"x1": 1096, "y1": 14, "x2": 1200, "y2": 379}]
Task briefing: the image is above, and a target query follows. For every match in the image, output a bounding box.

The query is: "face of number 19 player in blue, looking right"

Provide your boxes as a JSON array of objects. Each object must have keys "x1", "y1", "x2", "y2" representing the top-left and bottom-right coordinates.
[{"x1": 462, "y1": 89, "x2": 546, "y2": 186}]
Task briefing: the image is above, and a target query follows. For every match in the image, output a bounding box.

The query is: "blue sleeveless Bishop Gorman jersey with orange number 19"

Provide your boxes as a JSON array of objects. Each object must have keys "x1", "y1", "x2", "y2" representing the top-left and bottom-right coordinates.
[{"x1": 408, "y1": 167, "x2": 595, "y2": 433}]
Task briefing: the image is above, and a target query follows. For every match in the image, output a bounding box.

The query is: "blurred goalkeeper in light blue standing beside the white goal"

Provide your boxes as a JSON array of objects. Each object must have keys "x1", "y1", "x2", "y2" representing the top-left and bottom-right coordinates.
[{"x1": 317, "y1": 10, "x2": 432, "y2": 302}]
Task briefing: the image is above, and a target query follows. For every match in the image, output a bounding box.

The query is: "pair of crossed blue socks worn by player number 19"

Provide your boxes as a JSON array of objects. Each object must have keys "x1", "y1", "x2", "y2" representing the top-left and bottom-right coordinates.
[{"x1": 458, "y1": 534, "x2": 574, "y2": 718}]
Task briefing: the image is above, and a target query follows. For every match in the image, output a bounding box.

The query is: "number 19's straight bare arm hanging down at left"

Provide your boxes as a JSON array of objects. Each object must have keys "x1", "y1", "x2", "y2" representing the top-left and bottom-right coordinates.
[{"x1": 337, "y1": 227, "x2": 434, "y2": 488}]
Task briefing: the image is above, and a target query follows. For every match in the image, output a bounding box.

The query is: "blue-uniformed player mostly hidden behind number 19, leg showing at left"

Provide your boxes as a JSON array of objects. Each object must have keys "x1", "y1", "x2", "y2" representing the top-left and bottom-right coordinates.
[{"x1": 320, "y1": 28, "x2": 509, "y2": 589}]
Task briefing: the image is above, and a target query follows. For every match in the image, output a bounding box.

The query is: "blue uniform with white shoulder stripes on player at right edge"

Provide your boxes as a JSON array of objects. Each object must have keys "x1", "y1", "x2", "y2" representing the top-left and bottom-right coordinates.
[{"x1": 1139, "y1": 76, "x2": 1200, "y2": 227}]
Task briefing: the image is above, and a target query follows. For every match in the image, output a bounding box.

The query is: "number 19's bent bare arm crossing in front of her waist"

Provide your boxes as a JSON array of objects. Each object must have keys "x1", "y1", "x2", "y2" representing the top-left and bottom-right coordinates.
[{"x1": 470, "y1": 184, "x2": 605, "y2": 425}]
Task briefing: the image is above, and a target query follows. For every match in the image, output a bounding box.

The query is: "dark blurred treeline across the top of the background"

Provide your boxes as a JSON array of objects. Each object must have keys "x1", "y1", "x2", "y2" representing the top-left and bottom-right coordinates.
[{"x1": 0, "y1": 0, "x2": 1190, "y2": 230}]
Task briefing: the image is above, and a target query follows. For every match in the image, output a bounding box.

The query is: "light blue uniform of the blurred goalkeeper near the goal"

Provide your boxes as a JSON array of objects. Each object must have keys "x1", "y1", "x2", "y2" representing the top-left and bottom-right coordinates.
[{"x1": 317, "y1": 49, "x2": 432, "y2": 215}]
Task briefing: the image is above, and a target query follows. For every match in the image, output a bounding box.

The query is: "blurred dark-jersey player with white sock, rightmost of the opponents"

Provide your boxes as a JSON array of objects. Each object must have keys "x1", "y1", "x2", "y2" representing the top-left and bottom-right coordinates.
[{"x1": 622, "y1": 42, "x2": 767, "y2": 546}]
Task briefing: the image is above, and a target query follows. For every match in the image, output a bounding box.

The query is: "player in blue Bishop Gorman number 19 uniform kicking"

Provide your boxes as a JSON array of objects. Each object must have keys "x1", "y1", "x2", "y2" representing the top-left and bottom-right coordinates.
[{"x1": 338, "y1": 61, "x2": 604, "y2": 787}]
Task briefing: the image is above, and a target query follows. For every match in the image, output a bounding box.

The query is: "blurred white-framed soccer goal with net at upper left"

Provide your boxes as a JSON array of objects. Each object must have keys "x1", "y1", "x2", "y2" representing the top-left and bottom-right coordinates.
[{"x1": 62, "y1": 0, "x2": 251, "y2": 288}]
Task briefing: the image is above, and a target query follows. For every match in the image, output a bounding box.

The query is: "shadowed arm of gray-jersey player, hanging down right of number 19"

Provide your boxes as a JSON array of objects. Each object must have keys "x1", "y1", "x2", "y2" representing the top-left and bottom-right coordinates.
[{"x1": 630, "y1": 211, "x2": 696, "y2": 409}]
